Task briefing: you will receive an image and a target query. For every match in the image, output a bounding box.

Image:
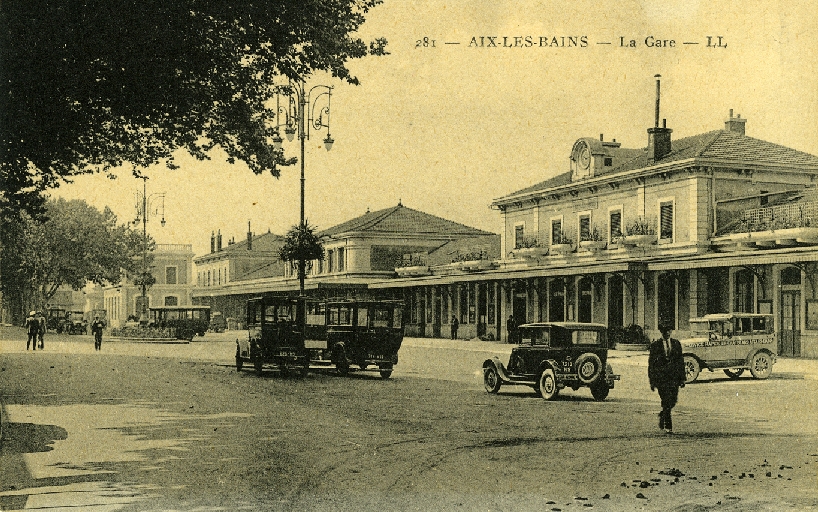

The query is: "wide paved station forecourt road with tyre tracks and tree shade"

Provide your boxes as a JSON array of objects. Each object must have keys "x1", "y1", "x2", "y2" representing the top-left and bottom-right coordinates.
[{"x1": 0, "y1": 329, "x2": 818, "y2": 511}]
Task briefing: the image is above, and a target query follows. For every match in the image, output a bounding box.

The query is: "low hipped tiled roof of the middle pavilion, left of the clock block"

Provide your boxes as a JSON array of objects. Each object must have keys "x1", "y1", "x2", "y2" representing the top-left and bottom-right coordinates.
[{"x1": 319, "y1": 204, "x2": 492, "y2": 236}]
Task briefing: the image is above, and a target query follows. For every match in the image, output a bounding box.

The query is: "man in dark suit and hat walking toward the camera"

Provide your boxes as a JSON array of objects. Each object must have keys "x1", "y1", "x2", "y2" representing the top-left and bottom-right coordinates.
[{"x1": 648, "y1": 325, "x2": 685, "y2": 434}]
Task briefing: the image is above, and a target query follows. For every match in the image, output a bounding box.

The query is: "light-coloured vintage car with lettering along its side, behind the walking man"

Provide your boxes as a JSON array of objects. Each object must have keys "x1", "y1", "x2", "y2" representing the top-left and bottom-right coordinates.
[{"x1": 680, "y1": 313, "x2": 778, "y2": 382}]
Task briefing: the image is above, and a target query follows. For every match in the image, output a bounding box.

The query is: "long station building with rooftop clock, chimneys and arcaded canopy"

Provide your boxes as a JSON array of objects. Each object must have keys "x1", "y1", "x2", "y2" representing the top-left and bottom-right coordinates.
[{"x1": 185, "y1": 100, "x2": 818, "y2": 358}]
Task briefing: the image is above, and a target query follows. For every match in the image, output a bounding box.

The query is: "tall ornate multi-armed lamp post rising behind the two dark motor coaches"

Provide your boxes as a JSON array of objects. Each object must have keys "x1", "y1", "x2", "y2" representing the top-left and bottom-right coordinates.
[{"x1": 273, "y1": 81, "x2": 335, "y2": 295}]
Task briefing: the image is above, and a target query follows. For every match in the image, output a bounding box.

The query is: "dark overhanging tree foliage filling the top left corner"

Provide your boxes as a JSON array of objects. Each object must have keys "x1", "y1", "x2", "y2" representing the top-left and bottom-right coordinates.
[{"x1": 0, "y1": 0, "x2": 386, "y2": 220}]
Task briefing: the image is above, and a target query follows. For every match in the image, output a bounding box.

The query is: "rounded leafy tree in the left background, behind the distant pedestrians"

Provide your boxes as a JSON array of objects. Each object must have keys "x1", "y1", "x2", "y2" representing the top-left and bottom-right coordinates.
[{"x1": 13, "y1": 199, "x2": 143, "y2": 309}]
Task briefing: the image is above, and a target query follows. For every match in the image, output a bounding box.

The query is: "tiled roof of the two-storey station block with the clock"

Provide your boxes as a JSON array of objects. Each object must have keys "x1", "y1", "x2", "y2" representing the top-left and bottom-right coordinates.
[{"x1": 497, "y1": 130, "x2": 818, "y2": 201}]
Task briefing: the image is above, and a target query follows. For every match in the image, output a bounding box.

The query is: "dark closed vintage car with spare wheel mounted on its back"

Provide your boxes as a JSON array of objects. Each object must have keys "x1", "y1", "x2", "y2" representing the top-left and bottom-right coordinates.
[{"x1": 483, "y1": 322, "x2": 619, "y2": 400}]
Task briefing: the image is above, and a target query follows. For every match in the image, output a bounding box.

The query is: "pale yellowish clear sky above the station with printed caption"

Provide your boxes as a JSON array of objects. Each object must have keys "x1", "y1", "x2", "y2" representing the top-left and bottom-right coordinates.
[{"x1": 52, "y1": 0, "x2": 818, "y2": 256}]
